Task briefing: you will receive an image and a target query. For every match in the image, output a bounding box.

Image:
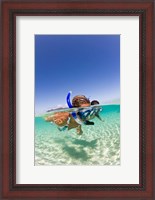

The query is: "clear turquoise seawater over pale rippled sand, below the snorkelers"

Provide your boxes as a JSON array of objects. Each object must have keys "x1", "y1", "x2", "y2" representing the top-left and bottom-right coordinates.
[{"x1": 35, "y1": 105, "x2": 120, "y2": 166}]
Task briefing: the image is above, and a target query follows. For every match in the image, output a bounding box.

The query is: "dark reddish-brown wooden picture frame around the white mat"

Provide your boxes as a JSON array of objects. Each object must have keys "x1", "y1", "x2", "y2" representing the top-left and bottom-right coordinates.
[{"x1": 0, "y1": 0, "x2": 155, "y2": 200}]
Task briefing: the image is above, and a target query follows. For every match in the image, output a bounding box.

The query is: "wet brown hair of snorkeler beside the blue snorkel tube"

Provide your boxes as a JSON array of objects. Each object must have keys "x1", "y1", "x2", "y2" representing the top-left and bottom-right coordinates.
[{"x1": 72, "y1": 95, "x2": 90, "y2": 107}]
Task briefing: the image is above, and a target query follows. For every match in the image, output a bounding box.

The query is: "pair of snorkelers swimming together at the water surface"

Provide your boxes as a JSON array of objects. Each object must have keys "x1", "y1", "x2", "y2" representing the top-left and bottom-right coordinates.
[{"x1": 45, "y1": 92, "x2": 103, "y2": 135}]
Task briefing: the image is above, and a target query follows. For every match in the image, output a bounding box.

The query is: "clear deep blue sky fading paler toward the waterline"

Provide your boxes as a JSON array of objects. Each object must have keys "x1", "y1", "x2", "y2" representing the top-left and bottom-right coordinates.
[{"x1": 35, "y1": 35, "x2": 120, "y2": 113}]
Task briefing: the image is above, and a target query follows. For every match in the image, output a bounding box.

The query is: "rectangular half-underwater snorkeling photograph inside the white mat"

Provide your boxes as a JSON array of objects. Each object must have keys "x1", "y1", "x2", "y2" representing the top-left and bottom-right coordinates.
[{"x1": 34, "y1": 34, "x2": 121, "y2": 166}]
